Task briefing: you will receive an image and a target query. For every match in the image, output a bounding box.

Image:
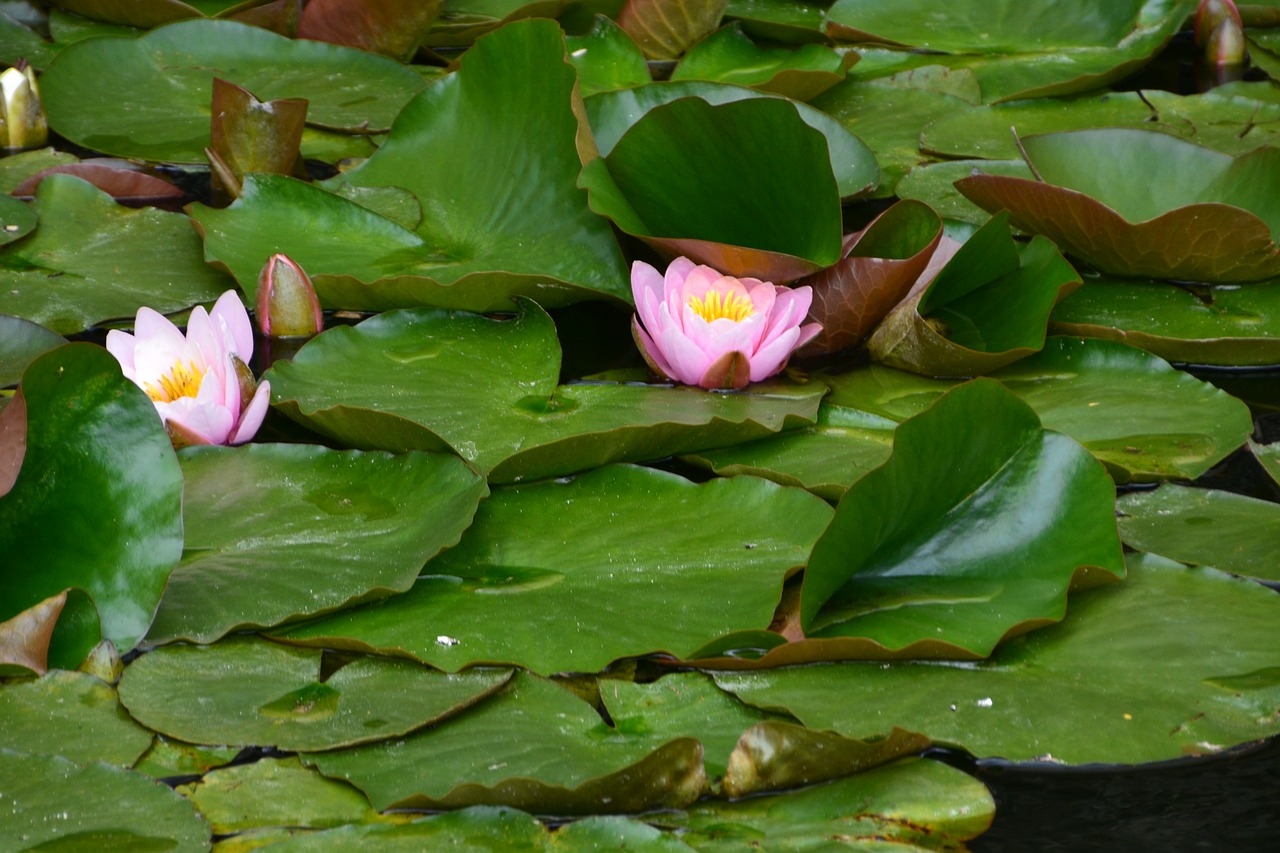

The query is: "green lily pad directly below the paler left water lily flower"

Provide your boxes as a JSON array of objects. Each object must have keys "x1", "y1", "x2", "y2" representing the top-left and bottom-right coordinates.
[{"x1": 147, "y1": 444, "x2": 488, "y2": 643}]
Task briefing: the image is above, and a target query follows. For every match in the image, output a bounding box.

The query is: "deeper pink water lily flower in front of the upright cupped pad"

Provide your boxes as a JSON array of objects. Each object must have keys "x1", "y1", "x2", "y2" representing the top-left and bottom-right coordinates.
[{"x1": 631, "y1": 257, "x2": 822, "y2": 388}]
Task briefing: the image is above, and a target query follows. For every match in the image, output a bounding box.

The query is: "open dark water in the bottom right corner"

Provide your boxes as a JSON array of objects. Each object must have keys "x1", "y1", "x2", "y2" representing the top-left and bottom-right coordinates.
[{"x1": 969, "y1": 738, "x2": 1280, "y2": 853}]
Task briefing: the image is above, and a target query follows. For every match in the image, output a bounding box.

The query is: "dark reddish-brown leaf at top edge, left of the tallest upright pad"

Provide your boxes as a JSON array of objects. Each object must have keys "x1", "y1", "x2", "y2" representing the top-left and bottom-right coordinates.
[{"x1": 298, "y1": 0, "x2": 440, "y2": 59}]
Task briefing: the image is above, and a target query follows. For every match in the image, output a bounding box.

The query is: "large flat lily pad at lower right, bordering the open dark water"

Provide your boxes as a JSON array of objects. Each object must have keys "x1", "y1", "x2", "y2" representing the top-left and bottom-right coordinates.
[{"x1": 716, "y1": 555, "x2": 1280, "y2": 765}]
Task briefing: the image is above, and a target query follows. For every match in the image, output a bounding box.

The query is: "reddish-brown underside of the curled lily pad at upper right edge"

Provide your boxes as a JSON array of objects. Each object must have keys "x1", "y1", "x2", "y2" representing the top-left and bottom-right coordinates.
[{"x1": 956, "y1": 174, "x2": 1280, "y2": 283}]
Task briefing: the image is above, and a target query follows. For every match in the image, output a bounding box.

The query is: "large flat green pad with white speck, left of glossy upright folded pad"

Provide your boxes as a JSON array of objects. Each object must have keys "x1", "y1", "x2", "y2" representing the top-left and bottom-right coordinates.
[{"x1": 280, "y1": 466, "x2": 831, "y2": 674}]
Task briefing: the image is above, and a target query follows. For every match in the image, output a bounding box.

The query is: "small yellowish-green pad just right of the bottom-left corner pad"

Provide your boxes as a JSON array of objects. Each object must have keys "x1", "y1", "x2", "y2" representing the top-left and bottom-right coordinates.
[{"x1": 183, "y1": 758, "x2": 388, "y2": 835}]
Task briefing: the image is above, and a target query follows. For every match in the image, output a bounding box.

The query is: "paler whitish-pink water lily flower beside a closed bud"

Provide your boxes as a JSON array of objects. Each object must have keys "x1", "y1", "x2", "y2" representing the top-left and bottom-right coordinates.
[{"x1": 106, "y1": 291, "x2": 271, "y2": 447}]
